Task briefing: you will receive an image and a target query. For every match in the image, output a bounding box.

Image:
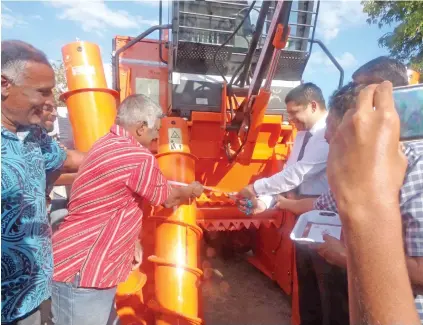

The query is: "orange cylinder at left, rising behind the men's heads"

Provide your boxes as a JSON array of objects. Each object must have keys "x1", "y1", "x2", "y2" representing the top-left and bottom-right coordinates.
[{"x1": 61, "y1": 41, "x2": 119, "y2": 152}]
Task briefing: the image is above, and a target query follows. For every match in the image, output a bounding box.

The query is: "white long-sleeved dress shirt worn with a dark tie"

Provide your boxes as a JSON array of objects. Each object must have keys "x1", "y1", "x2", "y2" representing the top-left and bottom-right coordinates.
[{"x1": 253, "y1": 114, "x2": 329, "y2": 207}]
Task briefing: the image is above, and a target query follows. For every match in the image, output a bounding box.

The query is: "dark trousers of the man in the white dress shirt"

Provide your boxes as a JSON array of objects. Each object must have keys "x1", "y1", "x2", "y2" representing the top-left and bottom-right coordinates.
[{"x1": 296, "y1": 245, "x2": 349, "y2": 325}]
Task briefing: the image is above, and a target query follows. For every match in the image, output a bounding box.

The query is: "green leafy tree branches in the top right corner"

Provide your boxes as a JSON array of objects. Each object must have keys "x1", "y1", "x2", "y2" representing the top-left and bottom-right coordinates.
[{"x1": 361, "y1": 0, "x2": 423, "y2": 76}]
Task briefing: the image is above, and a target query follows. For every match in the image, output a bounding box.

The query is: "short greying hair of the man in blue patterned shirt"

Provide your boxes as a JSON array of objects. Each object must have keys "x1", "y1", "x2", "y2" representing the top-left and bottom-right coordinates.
[{"x1": 1, "y1": 40, "x2": 51, "y2": 84}]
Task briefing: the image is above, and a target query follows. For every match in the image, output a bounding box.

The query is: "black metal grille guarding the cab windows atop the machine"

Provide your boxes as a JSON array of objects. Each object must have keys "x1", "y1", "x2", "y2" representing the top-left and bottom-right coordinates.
[{"x1": 173, "y1": 0, "x2": 316, "y2": 81}]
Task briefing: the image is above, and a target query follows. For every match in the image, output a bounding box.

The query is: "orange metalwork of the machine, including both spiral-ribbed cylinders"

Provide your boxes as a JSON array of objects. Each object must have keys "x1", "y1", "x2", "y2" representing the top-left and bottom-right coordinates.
[{"x1": 62, "y1": 29, "x2": 299, "y2": 325}]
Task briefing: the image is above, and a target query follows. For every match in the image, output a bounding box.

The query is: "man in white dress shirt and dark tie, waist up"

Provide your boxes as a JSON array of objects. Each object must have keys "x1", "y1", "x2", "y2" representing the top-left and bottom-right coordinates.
[{"x1": 238, "y1": 83, "x2": 329, "y2": 213}]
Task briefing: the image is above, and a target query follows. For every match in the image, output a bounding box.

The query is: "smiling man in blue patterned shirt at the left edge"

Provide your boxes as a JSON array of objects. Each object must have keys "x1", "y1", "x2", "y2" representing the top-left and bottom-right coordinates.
[{"x1": 1, "y1": 40, "x2": 80, "y2": 325}]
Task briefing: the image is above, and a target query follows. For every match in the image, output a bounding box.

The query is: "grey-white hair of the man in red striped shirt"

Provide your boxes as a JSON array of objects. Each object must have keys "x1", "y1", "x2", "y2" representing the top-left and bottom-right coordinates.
[{"x1": 116, "y1": 94, "x2": 163, "y2": 128}]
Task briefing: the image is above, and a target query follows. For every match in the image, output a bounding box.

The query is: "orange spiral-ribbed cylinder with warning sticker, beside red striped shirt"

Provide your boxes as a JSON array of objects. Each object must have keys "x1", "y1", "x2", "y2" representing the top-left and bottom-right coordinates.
[{"x1": 148, "y1": 117, "x2": 202, "y2": 325}]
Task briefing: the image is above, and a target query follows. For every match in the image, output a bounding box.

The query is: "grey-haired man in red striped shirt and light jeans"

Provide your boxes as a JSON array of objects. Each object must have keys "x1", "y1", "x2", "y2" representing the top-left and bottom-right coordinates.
[{"x1": 52, "y1": 95, "x2": 203, "y2": 325}]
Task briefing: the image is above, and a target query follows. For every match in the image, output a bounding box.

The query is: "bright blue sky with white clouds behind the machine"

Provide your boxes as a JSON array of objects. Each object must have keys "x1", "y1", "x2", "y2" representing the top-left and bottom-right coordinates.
[{"x1": 1, "y1": 0, "x2": 393, "y2": 98}]
